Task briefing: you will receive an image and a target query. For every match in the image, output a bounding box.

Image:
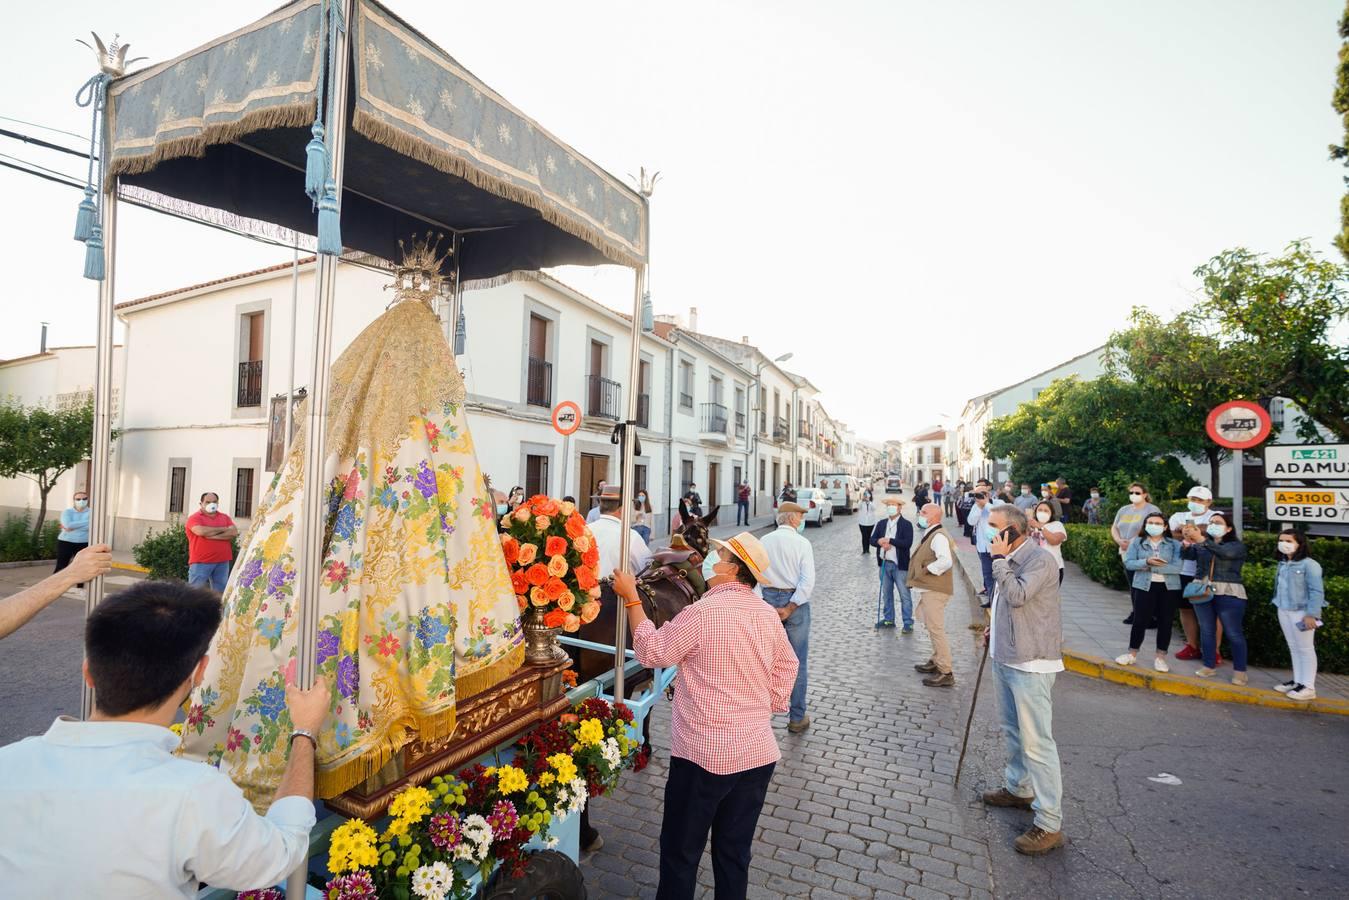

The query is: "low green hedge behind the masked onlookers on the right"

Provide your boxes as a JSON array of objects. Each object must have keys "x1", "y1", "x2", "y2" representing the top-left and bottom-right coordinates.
[{"x1": 1062, "y1": 525, "x2": 1349, "y2": 673}]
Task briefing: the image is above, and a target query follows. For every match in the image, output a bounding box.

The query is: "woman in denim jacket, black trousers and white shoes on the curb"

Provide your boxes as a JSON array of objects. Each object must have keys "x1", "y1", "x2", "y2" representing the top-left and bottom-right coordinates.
[{"x1": 1114, "y1": 513, "x2": 1180, "y2": 672}]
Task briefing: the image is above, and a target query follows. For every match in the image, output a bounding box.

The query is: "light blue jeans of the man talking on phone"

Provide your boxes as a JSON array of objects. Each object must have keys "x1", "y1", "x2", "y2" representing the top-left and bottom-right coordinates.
[{"x1": 993, "y1": 661, "x2": 1063, "y2": 831}]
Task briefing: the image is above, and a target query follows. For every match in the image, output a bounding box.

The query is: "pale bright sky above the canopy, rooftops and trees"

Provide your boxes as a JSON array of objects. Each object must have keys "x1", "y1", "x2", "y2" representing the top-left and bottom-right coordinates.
[{"x1": 0, "y1": 0, "x2": 1342, "y2": 439}]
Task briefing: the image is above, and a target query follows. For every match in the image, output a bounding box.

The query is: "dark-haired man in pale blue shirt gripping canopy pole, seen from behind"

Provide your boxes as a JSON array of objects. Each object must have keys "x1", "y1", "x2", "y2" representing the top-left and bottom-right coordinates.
[{"x1": 0, "y1": 582, "x2": 329, "y2": 897}]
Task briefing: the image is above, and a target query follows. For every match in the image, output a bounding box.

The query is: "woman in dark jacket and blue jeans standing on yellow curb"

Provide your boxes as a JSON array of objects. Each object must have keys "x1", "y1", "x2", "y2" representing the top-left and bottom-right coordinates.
[{"x1": 1180, "y1": 513, "x2": 1246, "y2": 684}]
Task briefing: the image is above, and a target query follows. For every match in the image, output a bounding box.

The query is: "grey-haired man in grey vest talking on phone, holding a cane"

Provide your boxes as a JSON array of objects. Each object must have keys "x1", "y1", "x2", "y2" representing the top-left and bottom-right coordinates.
[{"x1": 983, "y1": 503, "x2": 1063, "y2": 855}]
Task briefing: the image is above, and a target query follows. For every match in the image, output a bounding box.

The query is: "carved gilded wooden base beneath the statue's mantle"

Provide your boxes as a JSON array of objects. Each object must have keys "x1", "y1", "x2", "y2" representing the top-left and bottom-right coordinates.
[{"x1": 324, "y1": 656, "x2": 571, "y2": 820}]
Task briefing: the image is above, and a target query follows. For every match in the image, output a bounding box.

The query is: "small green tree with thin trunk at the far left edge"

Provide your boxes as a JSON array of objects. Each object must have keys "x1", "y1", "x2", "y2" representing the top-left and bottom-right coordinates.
[{"x1": 0, "y1": 402, "x2": 93, "y2": 545}]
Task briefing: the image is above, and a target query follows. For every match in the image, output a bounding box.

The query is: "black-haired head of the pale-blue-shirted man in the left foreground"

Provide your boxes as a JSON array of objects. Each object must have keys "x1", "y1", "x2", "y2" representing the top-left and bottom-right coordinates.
[{"x1": 85, "y1": 582, "x2": 221, "y2": 718}]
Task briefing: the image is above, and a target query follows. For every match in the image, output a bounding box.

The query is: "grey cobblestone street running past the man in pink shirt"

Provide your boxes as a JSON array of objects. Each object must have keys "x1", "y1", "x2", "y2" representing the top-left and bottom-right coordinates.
[{"x1": 583, "y1": 515, "x2": 992, "y2": 900}]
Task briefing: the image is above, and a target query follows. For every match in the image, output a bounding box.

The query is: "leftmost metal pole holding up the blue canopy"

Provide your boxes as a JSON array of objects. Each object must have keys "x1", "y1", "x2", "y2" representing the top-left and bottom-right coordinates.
[{"x1": 80, "y1": 183, "x2": 118, "y2": 719}]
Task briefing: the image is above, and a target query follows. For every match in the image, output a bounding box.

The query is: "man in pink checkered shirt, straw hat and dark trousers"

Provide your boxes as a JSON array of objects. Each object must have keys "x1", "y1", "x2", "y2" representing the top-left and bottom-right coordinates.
[{"x1": 614, "y1": 532, "x2": 797, "y2": 900}]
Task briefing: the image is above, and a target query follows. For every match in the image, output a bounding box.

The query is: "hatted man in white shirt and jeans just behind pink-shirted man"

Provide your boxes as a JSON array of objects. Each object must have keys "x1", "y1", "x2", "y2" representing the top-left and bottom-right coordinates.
[{"x1": 759, "y1": 501, "x2": 815, "y2": 734}]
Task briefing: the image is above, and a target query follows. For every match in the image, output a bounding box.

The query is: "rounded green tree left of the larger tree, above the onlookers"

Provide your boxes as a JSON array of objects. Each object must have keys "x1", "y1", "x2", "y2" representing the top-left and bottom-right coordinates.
[{"x1": 983, "y1": 375, "x2": 1192, "y2": 497}]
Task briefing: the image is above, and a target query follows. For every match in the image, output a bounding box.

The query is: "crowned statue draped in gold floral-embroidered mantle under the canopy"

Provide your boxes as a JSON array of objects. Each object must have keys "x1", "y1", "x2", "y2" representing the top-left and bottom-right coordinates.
[{"x1": 183, "y1": 236, "x2": 523, "y2": 803}]
